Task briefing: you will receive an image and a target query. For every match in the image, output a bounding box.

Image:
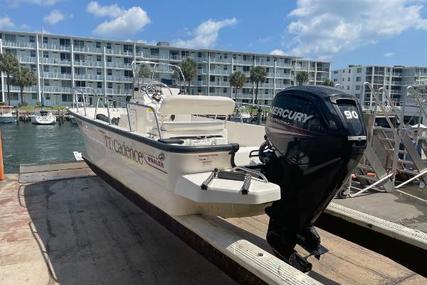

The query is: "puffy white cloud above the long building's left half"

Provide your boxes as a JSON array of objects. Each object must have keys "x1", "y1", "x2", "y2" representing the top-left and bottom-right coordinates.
[{"x1": 93, "y1": 7, "x2": 150, "y2": 37}]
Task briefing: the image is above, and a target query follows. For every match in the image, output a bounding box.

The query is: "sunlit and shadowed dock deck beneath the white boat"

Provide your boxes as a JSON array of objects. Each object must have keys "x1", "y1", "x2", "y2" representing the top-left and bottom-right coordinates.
[{"x1": 0, "y1": 162, "x2": 427, "y2": 284}]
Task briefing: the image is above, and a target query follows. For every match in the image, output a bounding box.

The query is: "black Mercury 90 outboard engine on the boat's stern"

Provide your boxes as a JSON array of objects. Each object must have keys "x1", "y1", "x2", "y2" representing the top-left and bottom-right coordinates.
[{"x1": 259, "y1": 86, "x2": 366, "y2": 272}]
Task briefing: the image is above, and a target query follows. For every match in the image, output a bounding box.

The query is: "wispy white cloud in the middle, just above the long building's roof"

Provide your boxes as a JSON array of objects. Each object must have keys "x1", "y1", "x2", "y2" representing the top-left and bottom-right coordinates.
[{"x1": 173, "y1": 18, "x2": 237, "y2": 48}]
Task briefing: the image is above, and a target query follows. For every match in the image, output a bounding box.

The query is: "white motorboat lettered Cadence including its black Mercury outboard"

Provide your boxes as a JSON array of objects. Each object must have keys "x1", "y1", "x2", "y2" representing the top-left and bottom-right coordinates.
[{"x1": 69, "y1": 61, "x2": 366, "y2": 272}]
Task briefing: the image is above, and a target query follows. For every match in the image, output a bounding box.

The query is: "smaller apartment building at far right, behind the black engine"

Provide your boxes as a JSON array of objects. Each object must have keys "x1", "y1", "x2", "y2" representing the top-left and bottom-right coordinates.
[{"x1": 331, "y1": 65, "x2": 427, "y2": 106}]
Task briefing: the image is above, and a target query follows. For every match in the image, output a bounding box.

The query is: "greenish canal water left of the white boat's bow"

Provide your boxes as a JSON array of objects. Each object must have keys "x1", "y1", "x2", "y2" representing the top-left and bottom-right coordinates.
[{"x1": 0, "y1": 122, "x2": 84, "y2": 173}]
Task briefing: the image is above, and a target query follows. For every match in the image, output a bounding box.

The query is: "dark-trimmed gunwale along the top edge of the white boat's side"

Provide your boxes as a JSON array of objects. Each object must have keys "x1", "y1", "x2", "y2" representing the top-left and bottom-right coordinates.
[{"x1": 68, "y1": 109, "x2": 239, "y2": 153}]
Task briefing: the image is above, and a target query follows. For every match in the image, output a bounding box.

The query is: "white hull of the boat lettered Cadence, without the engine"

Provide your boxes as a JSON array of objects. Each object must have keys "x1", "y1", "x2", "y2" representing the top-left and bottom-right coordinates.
[{"x1": 71, "y1": 111, "x2": 280, "y2": 217}]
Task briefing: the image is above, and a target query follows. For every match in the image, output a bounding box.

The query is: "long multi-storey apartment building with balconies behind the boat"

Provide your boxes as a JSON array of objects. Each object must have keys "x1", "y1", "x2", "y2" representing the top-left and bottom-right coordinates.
[{"x1": 0, "y1": 31, "x2": 330, "y2": 105}]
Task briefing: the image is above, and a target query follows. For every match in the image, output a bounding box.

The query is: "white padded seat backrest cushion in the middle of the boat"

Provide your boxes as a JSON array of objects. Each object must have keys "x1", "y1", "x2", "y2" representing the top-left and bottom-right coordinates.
[{"x1": 159, "y1": 95, "x2": 234, "y2": 115}]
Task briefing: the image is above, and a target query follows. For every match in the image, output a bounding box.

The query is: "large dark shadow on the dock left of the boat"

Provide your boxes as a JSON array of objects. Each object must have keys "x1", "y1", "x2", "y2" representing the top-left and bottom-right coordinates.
[{"x1": 21, "y1": 177, "x2": 235, "y2": 284}]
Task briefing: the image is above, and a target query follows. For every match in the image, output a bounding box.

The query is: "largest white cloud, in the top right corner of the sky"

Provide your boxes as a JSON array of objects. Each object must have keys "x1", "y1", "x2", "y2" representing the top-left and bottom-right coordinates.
[{"x1": 283, "y1": 0, "x2": 427, "y2": 58}]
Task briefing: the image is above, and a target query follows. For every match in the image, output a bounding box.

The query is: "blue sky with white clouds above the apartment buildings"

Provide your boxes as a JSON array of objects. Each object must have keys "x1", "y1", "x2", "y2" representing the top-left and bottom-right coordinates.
[{"x1": 0, "y1": 0, "x2": 427, "y2": 68}]
